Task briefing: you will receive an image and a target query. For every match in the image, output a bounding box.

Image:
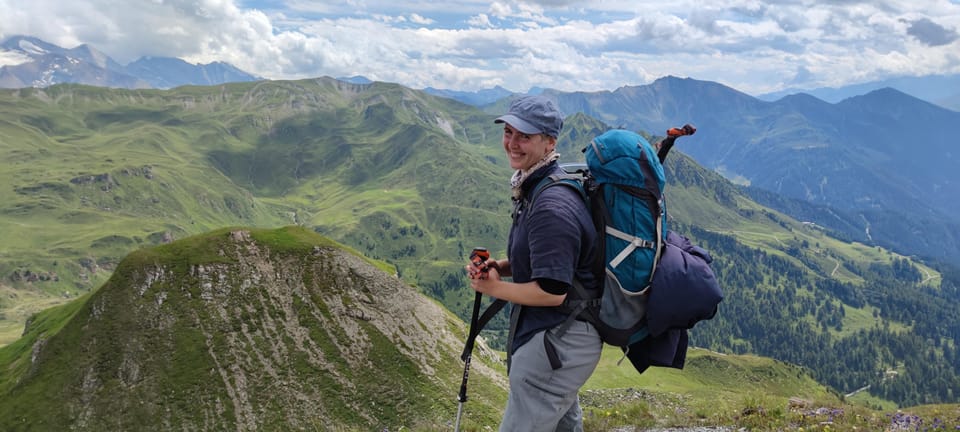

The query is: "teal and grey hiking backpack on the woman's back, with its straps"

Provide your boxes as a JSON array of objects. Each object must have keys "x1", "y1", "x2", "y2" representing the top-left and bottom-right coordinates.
[{"x1": 530, "y1": 129, "x2": 667, "y2": 347}]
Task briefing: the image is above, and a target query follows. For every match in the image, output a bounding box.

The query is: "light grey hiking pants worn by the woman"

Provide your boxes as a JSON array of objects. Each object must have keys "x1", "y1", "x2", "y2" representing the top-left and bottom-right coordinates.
[{"x1": 500, "y1": 321, "x2": 602, "y2": 432}]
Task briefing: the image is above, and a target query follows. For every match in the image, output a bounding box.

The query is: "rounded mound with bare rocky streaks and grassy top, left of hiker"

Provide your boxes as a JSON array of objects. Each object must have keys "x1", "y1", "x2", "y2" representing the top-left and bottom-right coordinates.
[{"x1": 0, "y1": 228, "x2": 506, "y2": 430}]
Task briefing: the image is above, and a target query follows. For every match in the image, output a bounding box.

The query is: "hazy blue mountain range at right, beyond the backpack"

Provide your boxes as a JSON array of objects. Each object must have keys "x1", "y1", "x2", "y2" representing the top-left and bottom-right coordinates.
[{"x1": 536, "y1": 77, "x2": 960, "y2": 264}]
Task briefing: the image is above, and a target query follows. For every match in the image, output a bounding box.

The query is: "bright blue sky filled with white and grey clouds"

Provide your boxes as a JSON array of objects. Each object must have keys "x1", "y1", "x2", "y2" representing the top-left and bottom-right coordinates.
[{"x1": 0, "y1": 0, "x2": 960, "y2": 95}]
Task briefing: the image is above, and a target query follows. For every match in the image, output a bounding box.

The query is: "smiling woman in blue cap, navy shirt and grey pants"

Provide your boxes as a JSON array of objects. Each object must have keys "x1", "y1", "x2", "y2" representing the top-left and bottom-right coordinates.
[{"x1": 466, "y1": 96, "x2": 602, "y2": 432}]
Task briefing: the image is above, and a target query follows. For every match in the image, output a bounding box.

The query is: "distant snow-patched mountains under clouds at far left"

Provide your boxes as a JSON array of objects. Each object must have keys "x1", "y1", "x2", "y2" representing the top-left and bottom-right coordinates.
[{"x1": 0, "y1": 36, "x2": 261, "y2": 89}]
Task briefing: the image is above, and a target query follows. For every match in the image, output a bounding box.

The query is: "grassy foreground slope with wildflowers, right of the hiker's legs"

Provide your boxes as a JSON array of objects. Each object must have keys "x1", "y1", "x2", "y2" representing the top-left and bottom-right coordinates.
[{"x1": 581, "y1": 348, "x2": 960, "y2": 432}]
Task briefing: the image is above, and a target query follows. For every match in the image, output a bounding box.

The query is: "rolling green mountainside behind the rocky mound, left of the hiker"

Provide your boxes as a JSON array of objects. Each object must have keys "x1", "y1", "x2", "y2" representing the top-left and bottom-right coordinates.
[{"x1": 0, "y1": 79, "x2": 506, "y2": 343}]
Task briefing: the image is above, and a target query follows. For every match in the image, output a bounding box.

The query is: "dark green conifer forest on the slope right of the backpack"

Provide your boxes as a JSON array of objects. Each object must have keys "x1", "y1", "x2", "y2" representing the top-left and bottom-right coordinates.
[{"x1": 684, "y1": 227, "x2": 960, "y2": 406}]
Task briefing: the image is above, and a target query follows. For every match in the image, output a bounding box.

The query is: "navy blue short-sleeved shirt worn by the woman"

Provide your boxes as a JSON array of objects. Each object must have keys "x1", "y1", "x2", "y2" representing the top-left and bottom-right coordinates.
[{"x1": 508, "y1": 163, "x2": 597, "y2": 351}]
